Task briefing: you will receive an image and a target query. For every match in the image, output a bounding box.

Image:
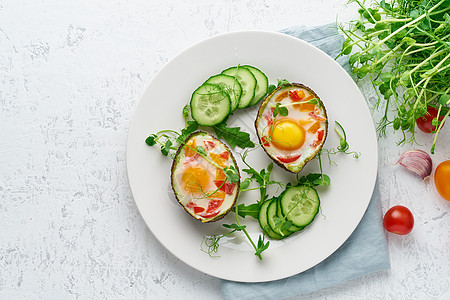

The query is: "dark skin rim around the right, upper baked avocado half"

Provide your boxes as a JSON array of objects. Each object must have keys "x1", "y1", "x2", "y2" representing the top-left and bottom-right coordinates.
[{"x1": 255, "y1": 82, "x2": 328, "y2": 174}]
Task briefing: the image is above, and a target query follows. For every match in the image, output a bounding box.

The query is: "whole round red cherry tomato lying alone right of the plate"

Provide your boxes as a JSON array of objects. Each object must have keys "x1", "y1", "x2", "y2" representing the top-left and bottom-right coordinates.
[{"x1": 383, "y1": 205, "x2": 414, "y2": 235}]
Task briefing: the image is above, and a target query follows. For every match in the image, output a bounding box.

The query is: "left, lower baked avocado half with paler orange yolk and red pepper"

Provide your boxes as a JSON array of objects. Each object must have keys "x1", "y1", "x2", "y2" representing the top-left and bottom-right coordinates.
[{"x1": 171, "y1": 131, "x2": 240, "y2": 223}]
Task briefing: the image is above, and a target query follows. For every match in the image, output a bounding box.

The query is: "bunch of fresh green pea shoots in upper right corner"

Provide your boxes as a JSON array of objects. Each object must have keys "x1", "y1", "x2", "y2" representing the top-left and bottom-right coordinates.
[{"x1": 338, "y1": 0, "x2": 450, "y2": 153}]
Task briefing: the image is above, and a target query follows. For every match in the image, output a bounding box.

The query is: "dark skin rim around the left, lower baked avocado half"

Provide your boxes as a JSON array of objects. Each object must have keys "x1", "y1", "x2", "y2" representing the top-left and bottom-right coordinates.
[{"x1": 170, "y1": 130, "x2": 241, "y2": 223}]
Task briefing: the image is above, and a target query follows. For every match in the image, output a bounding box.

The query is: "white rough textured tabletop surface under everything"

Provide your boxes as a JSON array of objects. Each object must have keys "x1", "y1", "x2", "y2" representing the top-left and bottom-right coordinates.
[{"x1": 0, "y1": 0, "x2": 450, "y2": 299}]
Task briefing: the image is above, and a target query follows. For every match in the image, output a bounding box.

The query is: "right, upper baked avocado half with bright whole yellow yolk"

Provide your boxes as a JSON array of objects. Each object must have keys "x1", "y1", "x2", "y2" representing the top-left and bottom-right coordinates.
[{"x1": 255, "y1": 83, "x2": 328, "y2": 173}]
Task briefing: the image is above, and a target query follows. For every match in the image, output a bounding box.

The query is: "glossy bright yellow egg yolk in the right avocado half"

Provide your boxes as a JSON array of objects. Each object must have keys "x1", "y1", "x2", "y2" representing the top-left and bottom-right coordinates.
[{"x1": 271, "y1": 119, "x2": 306, "y2": 151}]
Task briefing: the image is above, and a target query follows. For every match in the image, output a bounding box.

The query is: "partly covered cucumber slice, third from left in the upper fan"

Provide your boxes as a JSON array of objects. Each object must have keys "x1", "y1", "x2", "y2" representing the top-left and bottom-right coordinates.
[{"x1": 222, "y1": 66, "x2": 256, "y2": 108}]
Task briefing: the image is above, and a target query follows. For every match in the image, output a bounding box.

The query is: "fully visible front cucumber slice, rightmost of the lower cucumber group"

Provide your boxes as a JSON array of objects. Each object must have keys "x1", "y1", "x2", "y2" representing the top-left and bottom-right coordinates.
[{"x1": 280, "y1": 186, "x2": 320, "y2": 227}]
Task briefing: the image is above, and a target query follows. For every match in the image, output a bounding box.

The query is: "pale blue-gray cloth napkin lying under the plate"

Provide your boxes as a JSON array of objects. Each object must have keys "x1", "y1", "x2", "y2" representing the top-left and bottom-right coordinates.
[{"x1": 222, "y1": 24, "x2": 390, "y2": 300}]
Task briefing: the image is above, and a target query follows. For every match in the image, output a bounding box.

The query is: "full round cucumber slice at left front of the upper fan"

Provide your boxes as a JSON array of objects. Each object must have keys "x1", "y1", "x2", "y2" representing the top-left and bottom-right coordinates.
[{"x1": 190, "y1": 83, "x2": 231, "y2": 126}]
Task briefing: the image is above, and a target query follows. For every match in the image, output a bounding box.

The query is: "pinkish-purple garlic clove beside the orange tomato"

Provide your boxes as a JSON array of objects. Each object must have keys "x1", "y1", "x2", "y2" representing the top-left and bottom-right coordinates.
[{"x1": 396, "y1": 149, "x2": 433, "y2": 180}]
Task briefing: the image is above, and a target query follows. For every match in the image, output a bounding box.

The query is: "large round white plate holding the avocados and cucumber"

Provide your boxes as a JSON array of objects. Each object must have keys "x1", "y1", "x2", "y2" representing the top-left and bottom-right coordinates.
[{"x1": 127, "y1": 31, "x2": 378, "y2": 282}]
